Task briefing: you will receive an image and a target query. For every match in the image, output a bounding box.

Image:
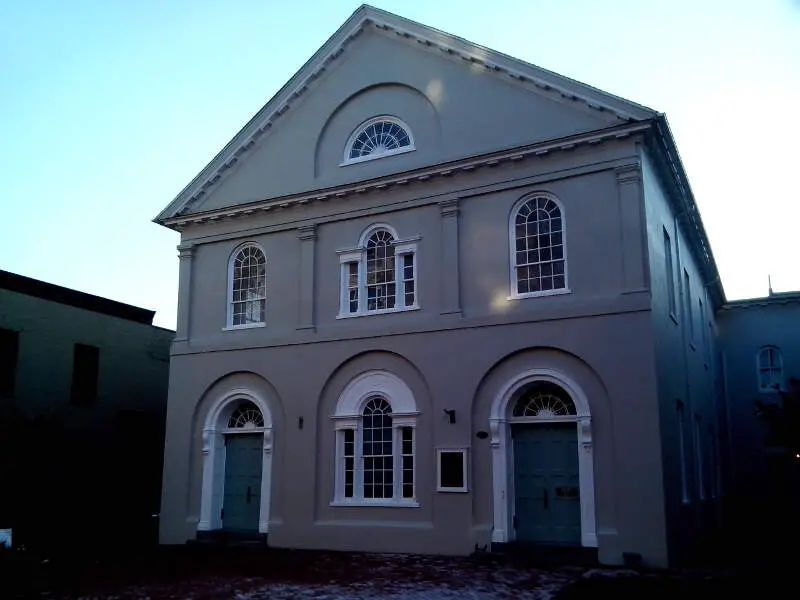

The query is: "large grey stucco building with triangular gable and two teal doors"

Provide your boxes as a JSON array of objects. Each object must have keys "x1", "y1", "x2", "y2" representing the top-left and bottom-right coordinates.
[{"x1": 156, "y1": 6, "x2": 724, "y2": 566}]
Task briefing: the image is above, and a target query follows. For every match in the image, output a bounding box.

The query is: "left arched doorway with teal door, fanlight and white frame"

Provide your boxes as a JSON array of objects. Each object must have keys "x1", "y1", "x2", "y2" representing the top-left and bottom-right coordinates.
[{"x1": 197, "y1": 390, "x2": 272, "y2": 534}]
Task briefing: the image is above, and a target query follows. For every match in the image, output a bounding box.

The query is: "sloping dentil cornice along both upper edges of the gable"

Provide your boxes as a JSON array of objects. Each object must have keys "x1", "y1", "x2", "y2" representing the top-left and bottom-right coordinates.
[{"x1": 154, "y1": 5, "x2": 656, "y2": 225}]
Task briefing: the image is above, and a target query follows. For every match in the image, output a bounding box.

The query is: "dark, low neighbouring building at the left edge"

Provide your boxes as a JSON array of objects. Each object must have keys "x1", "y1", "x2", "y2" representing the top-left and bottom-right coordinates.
[{"x1": 0, "y1": 271, "x2": 175, "y2": 548}]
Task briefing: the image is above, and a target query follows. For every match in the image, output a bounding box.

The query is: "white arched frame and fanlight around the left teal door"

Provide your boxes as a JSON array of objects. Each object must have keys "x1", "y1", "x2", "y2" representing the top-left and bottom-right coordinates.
[{"x1": 197, "y1": 388, "x2": 273, "y2": 534}]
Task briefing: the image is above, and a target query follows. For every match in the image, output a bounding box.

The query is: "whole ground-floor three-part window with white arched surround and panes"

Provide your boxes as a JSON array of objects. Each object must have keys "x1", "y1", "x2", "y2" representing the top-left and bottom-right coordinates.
[{"x1": 331, "y1": 370, "x2": 419, "y2": 507}]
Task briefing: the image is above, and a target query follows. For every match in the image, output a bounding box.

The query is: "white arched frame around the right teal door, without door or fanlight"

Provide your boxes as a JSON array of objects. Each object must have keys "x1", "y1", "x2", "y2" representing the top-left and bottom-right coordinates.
[{"x1": 489, "y1": 369, "x2": 597, "y2": 548}]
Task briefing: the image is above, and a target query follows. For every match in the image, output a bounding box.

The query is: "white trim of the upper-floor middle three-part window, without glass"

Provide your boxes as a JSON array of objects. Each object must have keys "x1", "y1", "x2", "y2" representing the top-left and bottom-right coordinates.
[{"x1": 336, "y1": 223, "x2": 422, "y2": 319}]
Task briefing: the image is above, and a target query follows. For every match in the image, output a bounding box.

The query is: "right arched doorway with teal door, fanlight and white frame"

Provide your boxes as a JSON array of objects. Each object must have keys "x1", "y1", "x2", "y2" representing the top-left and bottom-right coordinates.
[{"x1": 489, "y1": 369, "x2": 597, "y2": 547}]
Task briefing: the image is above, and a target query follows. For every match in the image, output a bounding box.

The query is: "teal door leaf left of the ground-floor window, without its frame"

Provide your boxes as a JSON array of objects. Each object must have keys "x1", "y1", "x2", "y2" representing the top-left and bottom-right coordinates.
[{"x1": 222, "y1": 434, "x2": 264, "y2": 531}]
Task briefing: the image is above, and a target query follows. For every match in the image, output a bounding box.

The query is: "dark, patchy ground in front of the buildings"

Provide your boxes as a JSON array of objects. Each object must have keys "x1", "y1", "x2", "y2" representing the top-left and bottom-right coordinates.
[{"x1": 0, "y1": 548, "x2": 764, "y2": 600}]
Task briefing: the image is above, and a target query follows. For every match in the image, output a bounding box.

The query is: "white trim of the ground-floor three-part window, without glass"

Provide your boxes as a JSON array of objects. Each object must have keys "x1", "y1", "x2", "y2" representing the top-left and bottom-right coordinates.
[{"x1": 330, "y1": 371, "x2": 419, "y2": 508}]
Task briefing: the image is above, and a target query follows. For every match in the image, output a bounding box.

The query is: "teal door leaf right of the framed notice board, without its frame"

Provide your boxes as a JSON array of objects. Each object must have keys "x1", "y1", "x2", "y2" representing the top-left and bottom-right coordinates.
[{"x1": 512, "y1": 423, "x2": 581, "y2": 545}]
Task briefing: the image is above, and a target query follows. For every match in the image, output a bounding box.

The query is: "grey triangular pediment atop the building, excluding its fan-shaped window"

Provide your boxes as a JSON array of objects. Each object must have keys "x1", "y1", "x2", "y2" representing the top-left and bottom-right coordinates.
[{"x1": 156, "y1": 6, "x2": 656, "y2": 223}]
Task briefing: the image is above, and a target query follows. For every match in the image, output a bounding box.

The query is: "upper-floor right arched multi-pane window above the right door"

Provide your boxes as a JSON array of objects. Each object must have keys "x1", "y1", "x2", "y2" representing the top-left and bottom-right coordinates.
[{"x1": 509, "y1": 194, "x2": 567, "y2": 297}]
